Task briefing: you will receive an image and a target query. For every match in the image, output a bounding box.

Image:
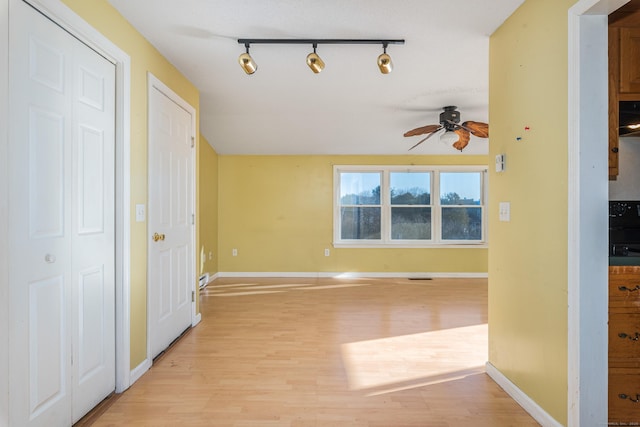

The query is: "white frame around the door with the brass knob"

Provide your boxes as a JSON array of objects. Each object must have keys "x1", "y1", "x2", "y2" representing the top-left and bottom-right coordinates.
[{"x1": 147, "y1": 71, "x2": 202, "y2": 366}]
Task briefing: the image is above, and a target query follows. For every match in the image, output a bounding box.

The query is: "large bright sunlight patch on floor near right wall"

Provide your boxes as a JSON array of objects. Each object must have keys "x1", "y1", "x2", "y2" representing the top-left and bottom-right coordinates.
[{"x1": 341, "y1": 324, "x2": 488, "y2": 394}]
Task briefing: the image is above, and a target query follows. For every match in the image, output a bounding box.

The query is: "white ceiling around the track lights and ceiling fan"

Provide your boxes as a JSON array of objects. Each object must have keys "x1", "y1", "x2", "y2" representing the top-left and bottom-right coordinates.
[{"x1": 109, "y1": 0, "x2": 524, "y2": 155}]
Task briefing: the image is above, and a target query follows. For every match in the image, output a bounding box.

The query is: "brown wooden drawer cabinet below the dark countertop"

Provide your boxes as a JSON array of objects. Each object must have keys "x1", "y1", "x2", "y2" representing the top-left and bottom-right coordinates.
[{"x1": 609, "y1": 266, "x2": 640, "y2": 425}]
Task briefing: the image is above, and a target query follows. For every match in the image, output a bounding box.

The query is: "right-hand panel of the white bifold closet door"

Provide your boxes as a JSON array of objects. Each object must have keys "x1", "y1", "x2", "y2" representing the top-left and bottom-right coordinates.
[{"x1": 71, "y1": 10, "x2": 115, "y2": 422}]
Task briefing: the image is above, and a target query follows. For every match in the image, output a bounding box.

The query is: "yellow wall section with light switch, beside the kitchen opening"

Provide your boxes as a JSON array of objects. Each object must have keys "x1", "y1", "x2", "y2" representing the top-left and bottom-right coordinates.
[{"x1": 489, "y1": 0, "x2": 576, "y2": 424}]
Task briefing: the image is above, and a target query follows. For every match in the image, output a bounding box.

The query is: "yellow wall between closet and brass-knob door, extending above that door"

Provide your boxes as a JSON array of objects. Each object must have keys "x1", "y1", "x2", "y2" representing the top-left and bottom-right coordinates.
[{"x1": 63, "y1": 0, "x2": 199, "y2": 369}]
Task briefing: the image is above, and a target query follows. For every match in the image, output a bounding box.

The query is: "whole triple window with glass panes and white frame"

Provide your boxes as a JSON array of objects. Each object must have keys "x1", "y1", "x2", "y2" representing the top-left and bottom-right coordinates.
[{"x1": 334, "y1": 166, "x2": 487, "y2": 247}]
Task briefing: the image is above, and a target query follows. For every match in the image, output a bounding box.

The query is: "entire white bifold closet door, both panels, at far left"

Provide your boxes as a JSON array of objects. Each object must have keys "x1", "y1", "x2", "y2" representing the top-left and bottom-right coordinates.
[{"x1": 9, "y1": 0, "x2": 115, "y2": 426}]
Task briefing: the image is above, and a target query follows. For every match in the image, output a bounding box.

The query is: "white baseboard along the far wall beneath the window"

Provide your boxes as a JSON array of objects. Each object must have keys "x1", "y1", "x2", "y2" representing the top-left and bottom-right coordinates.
[{"x1": 212, "y1": 271, "x2": 488, "y2": 280}]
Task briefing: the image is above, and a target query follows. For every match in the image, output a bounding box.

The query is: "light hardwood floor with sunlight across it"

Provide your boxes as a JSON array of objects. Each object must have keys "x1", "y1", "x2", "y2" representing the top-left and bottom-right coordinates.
[{"x1": 85, "y1": 278, "x2": 538, "y2": 427}]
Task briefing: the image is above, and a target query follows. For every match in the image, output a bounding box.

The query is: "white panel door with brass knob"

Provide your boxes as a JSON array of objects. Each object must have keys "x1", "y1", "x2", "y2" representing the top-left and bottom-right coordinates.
[{"x1": 148, "y1": 82, "x2": 195, "y2": 358}]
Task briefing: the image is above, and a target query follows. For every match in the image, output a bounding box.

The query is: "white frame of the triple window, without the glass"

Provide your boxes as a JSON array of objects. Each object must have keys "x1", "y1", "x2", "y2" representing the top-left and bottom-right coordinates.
[{"x1": 333, "y1": 165, "x2": 488, "y2": 248}]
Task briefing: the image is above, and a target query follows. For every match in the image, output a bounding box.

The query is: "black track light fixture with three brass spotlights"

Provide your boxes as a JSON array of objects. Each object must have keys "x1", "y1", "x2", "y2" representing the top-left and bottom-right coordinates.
[{"x1": 238, "y1": 39, "x2": 404, "y2": 74}]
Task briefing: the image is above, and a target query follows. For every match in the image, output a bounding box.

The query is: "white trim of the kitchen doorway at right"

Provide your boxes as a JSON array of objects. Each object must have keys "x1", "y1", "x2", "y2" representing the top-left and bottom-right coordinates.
[{"x1": 567, "y1": 0, "x2": 629, "y2": 427}]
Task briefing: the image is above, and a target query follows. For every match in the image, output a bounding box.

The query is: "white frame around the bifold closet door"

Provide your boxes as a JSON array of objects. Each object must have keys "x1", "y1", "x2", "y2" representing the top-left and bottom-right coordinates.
[{"x1": 0, "y1": 0, "x2": 131, "y2": 425}]
